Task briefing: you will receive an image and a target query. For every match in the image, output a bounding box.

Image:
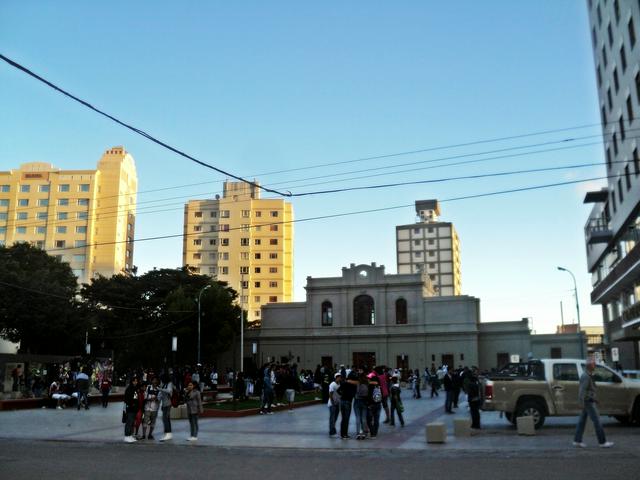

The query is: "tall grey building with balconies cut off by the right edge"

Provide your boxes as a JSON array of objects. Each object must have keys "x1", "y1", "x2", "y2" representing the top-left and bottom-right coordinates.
[{"x1": 584, "y1": 0, "x2": 640, "y2": 368}]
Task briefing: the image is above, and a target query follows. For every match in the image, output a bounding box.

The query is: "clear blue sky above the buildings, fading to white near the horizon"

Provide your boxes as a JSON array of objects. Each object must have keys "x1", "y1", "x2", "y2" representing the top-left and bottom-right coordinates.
[{"x1": 0, "y1": 0, "x2": 605, "y2": 333}]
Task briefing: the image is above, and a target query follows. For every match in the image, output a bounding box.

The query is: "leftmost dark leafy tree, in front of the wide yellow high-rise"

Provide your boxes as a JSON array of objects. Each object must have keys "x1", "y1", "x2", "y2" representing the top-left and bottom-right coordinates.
[{"x1": 0, "y1": 243, "x2": 86, "y2": 355}]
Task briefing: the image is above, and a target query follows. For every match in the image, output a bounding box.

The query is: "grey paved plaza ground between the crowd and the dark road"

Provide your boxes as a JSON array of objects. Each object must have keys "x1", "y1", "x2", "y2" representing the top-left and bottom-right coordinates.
[{"x1": 0, "y1": 391, "x2": 640, "y2": 458}]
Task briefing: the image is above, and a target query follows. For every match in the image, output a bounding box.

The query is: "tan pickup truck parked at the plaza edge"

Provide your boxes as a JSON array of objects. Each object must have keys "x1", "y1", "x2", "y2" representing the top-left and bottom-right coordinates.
[{"x1": 482, "y1": 358, "x2": 640, "y2": 428}]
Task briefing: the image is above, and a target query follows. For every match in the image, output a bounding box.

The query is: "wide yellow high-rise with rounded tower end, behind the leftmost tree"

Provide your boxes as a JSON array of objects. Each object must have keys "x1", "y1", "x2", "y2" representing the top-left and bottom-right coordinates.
[{"x1": 0, "y1": 147, "x2": 138, "y2": 282}]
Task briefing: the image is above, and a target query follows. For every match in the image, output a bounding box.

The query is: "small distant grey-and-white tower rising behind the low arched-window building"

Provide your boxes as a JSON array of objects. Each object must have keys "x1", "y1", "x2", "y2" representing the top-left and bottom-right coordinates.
[{"x1": 396, "y1": 200, "x2": 462, "y2": 296}]
